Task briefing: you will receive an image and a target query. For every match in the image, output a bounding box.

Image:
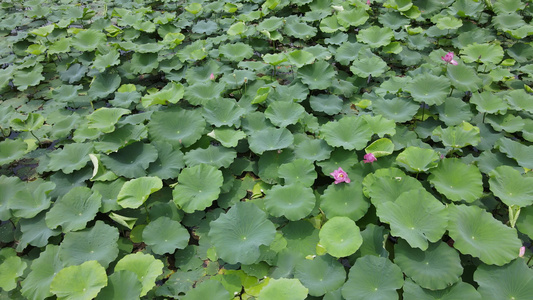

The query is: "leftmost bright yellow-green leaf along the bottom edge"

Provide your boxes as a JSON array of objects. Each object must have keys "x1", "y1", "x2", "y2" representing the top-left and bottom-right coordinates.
[{"x1": 50, "y1": 260, "x2": 107, "y2": 300}]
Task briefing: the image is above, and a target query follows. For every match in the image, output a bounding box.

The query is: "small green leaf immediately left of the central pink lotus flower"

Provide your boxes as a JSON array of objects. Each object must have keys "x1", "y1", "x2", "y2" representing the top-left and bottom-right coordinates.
[{"x1": 279, "y1": 159, "x2": 317, "y2": 187}]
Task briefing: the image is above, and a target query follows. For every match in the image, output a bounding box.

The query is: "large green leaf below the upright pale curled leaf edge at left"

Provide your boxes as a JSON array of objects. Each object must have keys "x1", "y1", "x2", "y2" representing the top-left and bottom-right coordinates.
[{"x1": 46, "y1": 186, "x2": 102, "y2": 232}]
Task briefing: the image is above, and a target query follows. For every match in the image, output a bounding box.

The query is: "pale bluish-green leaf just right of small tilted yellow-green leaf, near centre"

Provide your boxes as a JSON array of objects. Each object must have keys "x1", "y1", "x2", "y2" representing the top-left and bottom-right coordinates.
[{"x1": 248, "y1": 128, "x2": 294, "y2": 154}]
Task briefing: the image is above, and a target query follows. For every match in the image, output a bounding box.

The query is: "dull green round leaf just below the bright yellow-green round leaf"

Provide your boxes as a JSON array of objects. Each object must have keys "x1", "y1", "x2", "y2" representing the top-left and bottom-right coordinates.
[{"x1": 294, "y1": 255, "x2": 346, "y2": 296}]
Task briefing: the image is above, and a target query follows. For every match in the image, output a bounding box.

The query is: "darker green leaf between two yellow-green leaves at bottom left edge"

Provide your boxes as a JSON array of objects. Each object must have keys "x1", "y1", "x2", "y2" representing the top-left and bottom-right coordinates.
[{"x1": 95, "y1": 270, "x2": 142, "y2": 300}]
